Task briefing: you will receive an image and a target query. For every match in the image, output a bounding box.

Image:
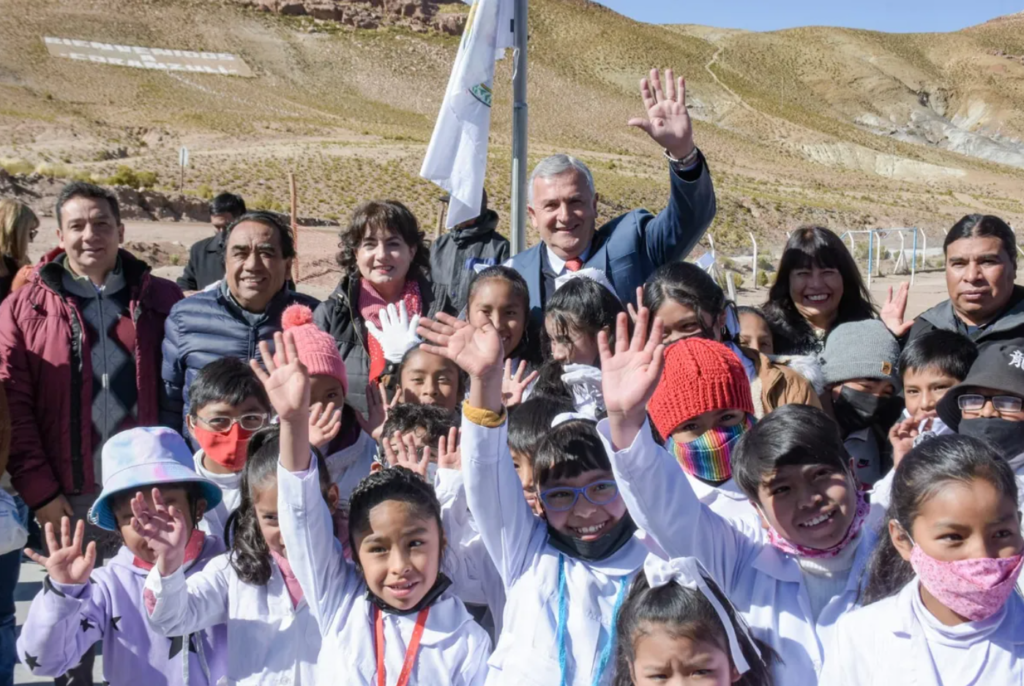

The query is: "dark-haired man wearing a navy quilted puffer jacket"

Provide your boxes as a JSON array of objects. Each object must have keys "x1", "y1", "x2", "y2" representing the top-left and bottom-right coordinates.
[{"x1": 162, "y1": 212, "x2": 319, "y2": 437}]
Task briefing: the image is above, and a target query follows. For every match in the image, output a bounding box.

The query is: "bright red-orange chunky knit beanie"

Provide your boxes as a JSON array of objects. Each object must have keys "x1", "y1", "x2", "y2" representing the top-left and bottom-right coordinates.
[{"x1": 647, "y1": 338, "x2": 754, "y2": 439}]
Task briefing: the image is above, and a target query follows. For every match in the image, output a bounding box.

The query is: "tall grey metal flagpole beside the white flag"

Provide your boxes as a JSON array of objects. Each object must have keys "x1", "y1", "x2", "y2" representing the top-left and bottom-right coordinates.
[{"x1": 509, "y1": 0, "x2": 528, "y2": 255}]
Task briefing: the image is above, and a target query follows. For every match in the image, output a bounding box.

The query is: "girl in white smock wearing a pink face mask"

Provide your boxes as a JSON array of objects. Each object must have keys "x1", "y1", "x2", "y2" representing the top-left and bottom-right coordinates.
[{"x1": 821, "y1": 436, "x2": 1024, "y2": 686}]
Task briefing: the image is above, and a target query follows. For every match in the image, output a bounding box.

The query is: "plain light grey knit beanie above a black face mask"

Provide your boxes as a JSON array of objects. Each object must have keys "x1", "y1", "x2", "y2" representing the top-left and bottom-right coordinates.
[{"x1": 821, "y1": 319, "x2": 902, "y2": 391}]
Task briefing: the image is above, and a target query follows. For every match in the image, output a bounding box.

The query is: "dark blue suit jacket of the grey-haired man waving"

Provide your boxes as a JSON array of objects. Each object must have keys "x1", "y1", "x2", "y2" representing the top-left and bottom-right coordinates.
[{"x1": 512, "y1": 156, "x2": 716, "y2": 327}]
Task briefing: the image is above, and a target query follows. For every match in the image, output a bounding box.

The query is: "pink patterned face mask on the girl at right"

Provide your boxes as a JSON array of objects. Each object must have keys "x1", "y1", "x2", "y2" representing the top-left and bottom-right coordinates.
[{"x1": 910, "y1": 544, "x2": 1024, "y2": 621}]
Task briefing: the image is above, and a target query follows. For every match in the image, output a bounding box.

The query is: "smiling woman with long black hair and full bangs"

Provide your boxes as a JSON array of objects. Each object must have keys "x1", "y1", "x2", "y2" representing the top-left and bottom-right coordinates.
[{"x1": 762, "y1": 226, "x2": 876, "y2": 355}]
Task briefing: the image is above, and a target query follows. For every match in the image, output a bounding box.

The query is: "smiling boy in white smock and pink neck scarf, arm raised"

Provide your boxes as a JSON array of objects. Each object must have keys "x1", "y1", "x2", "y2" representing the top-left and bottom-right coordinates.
[{"x1": 598, "y1": 308, "x2": 873, "y2": 686}]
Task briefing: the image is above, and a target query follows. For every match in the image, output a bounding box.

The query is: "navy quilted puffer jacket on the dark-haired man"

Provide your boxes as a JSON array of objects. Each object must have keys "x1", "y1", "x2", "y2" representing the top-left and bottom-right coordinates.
[{"x1": 160, "y1": 288, "x2": 319, "y2": 438}]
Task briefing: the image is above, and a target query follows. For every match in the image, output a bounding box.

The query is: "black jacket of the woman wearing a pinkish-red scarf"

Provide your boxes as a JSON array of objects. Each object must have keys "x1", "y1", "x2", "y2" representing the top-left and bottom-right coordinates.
[{"x1": 313, "y1": 275, "x2": 456, "y2": 417}]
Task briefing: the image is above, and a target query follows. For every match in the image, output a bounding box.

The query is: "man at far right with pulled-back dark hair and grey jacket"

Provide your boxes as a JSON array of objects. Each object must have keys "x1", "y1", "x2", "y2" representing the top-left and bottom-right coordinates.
[{"x1": 910, "y1": 214, "x2": 1024, "y2": 345}]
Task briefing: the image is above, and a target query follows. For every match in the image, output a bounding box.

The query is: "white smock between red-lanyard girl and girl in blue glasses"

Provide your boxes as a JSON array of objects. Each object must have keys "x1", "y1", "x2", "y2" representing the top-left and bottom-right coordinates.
[{"x1": 434, "y1": 469, "x2": 505, "y2": 636}]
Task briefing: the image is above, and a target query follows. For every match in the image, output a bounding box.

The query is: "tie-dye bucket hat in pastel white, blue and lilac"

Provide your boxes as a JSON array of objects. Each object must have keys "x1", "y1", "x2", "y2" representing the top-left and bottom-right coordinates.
[{"x1": 89, "y1": 427, "x2": 223, "y2": 531}]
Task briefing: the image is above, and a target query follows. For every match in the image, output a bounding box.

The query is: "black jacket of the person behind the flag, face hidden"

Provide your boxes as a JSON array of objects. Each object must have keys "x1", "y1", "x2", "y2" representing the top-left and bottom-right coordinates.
[{"x1": 430, "y1": 210, "x2": 509, "y2": 312}]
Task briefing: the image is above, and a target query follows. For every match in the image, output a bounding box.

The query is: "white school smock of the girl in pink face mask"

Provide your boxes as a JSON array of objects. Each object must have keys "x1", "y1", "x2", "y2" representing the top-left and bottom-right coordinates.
[{"x1": 821, "y1": 578, "x2": 1024, "y2": 686}]
